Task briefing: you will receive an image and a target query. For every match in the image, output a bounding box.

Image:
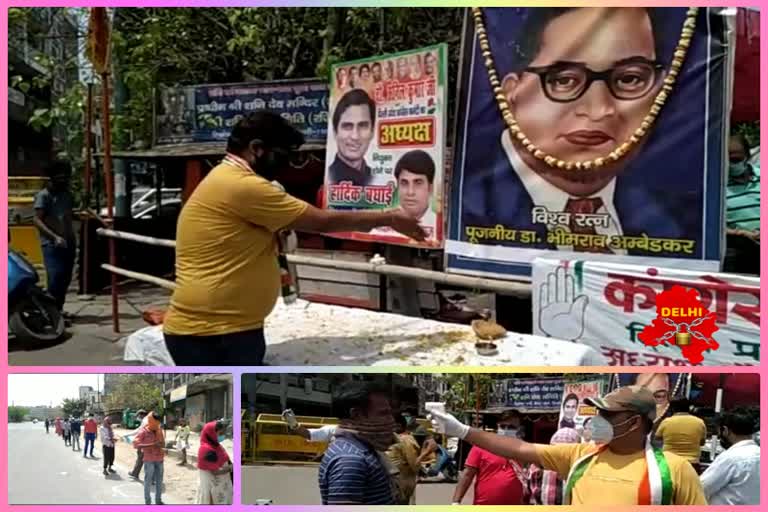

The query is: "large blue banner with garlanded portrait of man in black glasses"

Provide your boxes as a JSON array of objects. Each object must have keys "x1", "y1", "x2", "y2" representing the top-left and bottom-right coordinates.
[{"x1": 445, "y1": 7, "x2": 733, "y2": 277}]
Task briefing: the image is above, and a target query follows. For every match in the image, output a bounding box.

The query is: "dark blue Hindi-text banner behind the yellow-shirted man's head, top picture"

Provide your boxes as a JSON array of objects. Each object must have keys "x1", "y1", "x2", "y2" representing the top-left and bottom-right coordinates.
[{"x1": 155, "y1": 79, "x2": 328, "y2": 144}]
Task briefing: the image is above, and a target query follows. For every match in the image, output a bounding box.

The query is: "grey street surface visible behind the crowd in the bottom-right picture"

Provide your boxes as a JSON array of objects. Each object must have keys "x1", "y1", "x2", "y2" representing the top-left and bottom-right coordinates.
[{"x1": 242, "y1": 465, "x2": 472, "y2": 505}]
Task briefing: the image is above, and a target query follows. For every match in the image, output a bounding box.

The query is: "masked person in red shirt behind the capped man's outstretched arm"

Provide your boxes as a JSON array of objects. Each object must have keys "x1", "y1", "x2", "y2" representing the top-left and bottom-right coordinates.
[{"x1": 453, "y1": 411, "x2": 526, "y2": 505}]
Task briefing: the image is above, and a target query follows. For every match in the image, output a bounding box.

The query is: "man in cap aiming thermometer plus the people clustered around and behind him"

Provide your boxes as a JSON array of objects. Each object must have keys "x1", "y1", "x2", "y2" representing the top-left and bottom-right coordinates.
[{"x1": 431, "y1": 386, "x2": 760, "y2": 505}]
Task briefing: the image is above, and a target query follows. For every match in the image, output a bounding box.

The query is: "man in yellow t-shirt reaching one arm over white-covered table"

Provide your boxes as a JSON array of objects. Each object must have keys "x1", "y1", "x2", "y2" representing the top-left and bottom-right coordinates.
[{"x1": 163, "y1": 111, "x2": 426, "y2": 366}]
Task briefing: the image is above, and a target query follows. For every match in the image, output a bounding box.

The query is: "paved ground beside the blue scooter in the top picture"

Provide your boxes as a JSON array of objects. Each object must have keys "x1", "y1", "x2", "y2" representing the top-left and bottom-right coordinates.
[{"x1": 8, "y1": 283, "x2": 170, "y2": 366}]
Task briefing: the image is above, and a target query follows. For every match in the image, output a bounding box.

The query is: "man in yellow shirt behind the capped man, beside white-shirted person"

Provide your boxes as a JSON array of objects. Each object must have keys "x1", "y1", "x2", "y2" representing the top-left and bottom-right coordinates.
[{"x1": 656, "y1": 398, "x2": 707, "y2": 473}]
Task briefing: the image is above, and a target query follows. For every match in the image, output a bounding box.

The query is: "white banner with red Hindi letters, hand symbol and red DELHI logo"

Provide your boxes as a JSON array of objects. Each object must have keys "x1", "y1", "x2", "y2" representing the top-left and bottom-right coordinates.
[{"x1": 533, "y1": 258, "x2": 760, "y2": 366}]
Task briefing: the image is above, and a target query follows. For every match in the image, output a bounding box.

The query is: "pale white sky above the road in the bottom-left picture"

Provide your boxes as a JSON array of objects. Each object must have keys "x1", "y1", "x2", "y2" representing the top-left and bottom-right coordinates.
[{"x1": 8, "y1": 373, "x2": 104, "y2": 407}]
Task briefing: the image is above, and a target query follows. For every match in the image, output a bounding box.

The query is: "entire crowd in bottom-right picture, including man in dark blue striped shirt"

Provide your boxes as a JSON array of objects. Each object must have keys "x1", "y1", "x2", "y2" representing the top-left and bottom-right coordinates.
[{"x1": 283, "y1": 381, "x2": 760, "y2": 505}]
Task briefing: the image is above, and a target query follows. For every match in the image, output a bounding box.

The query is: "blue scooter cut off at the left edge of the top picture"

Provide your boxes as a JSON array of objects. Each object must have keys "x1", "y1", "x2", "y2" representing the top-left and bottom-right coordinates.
[{"x1": 8, "y1": 250, "x2": 64, "y2": 343}]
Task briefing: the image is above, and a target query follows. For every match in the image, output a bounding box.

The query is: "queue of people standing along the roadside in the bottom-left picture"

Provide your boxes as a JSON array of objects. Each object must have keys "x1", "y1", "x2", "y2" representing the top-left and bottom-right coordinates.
[{"x1": 45, "y1": 409, "x2": 233, "y2": 505}]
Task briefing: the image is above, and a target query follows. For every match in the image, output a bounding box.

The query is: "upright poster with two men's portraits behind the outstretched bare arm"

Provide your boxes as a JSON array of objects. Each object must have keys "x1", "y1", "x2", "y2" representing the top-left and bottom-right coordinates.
[{"x1": 325, "y1": 45, "x2": 448, "y2": 247}]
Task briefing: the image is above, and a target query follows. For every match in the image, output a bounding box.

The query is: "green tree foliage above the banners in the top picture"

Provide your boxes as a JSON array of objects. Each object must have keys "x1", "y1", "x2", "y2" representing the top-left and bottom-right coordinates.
[{"x1": 9, "y1": 7, "x2": 463, "y2": 158}]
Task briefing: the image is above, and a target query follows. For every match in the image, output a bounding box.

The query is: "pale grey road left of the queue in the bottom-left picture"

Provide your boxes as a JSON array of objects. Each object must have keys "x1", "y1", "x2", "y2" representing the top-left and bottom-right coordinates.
[{"x1": 8, "y1": 422, "x2": 182, "y2": 505}]
